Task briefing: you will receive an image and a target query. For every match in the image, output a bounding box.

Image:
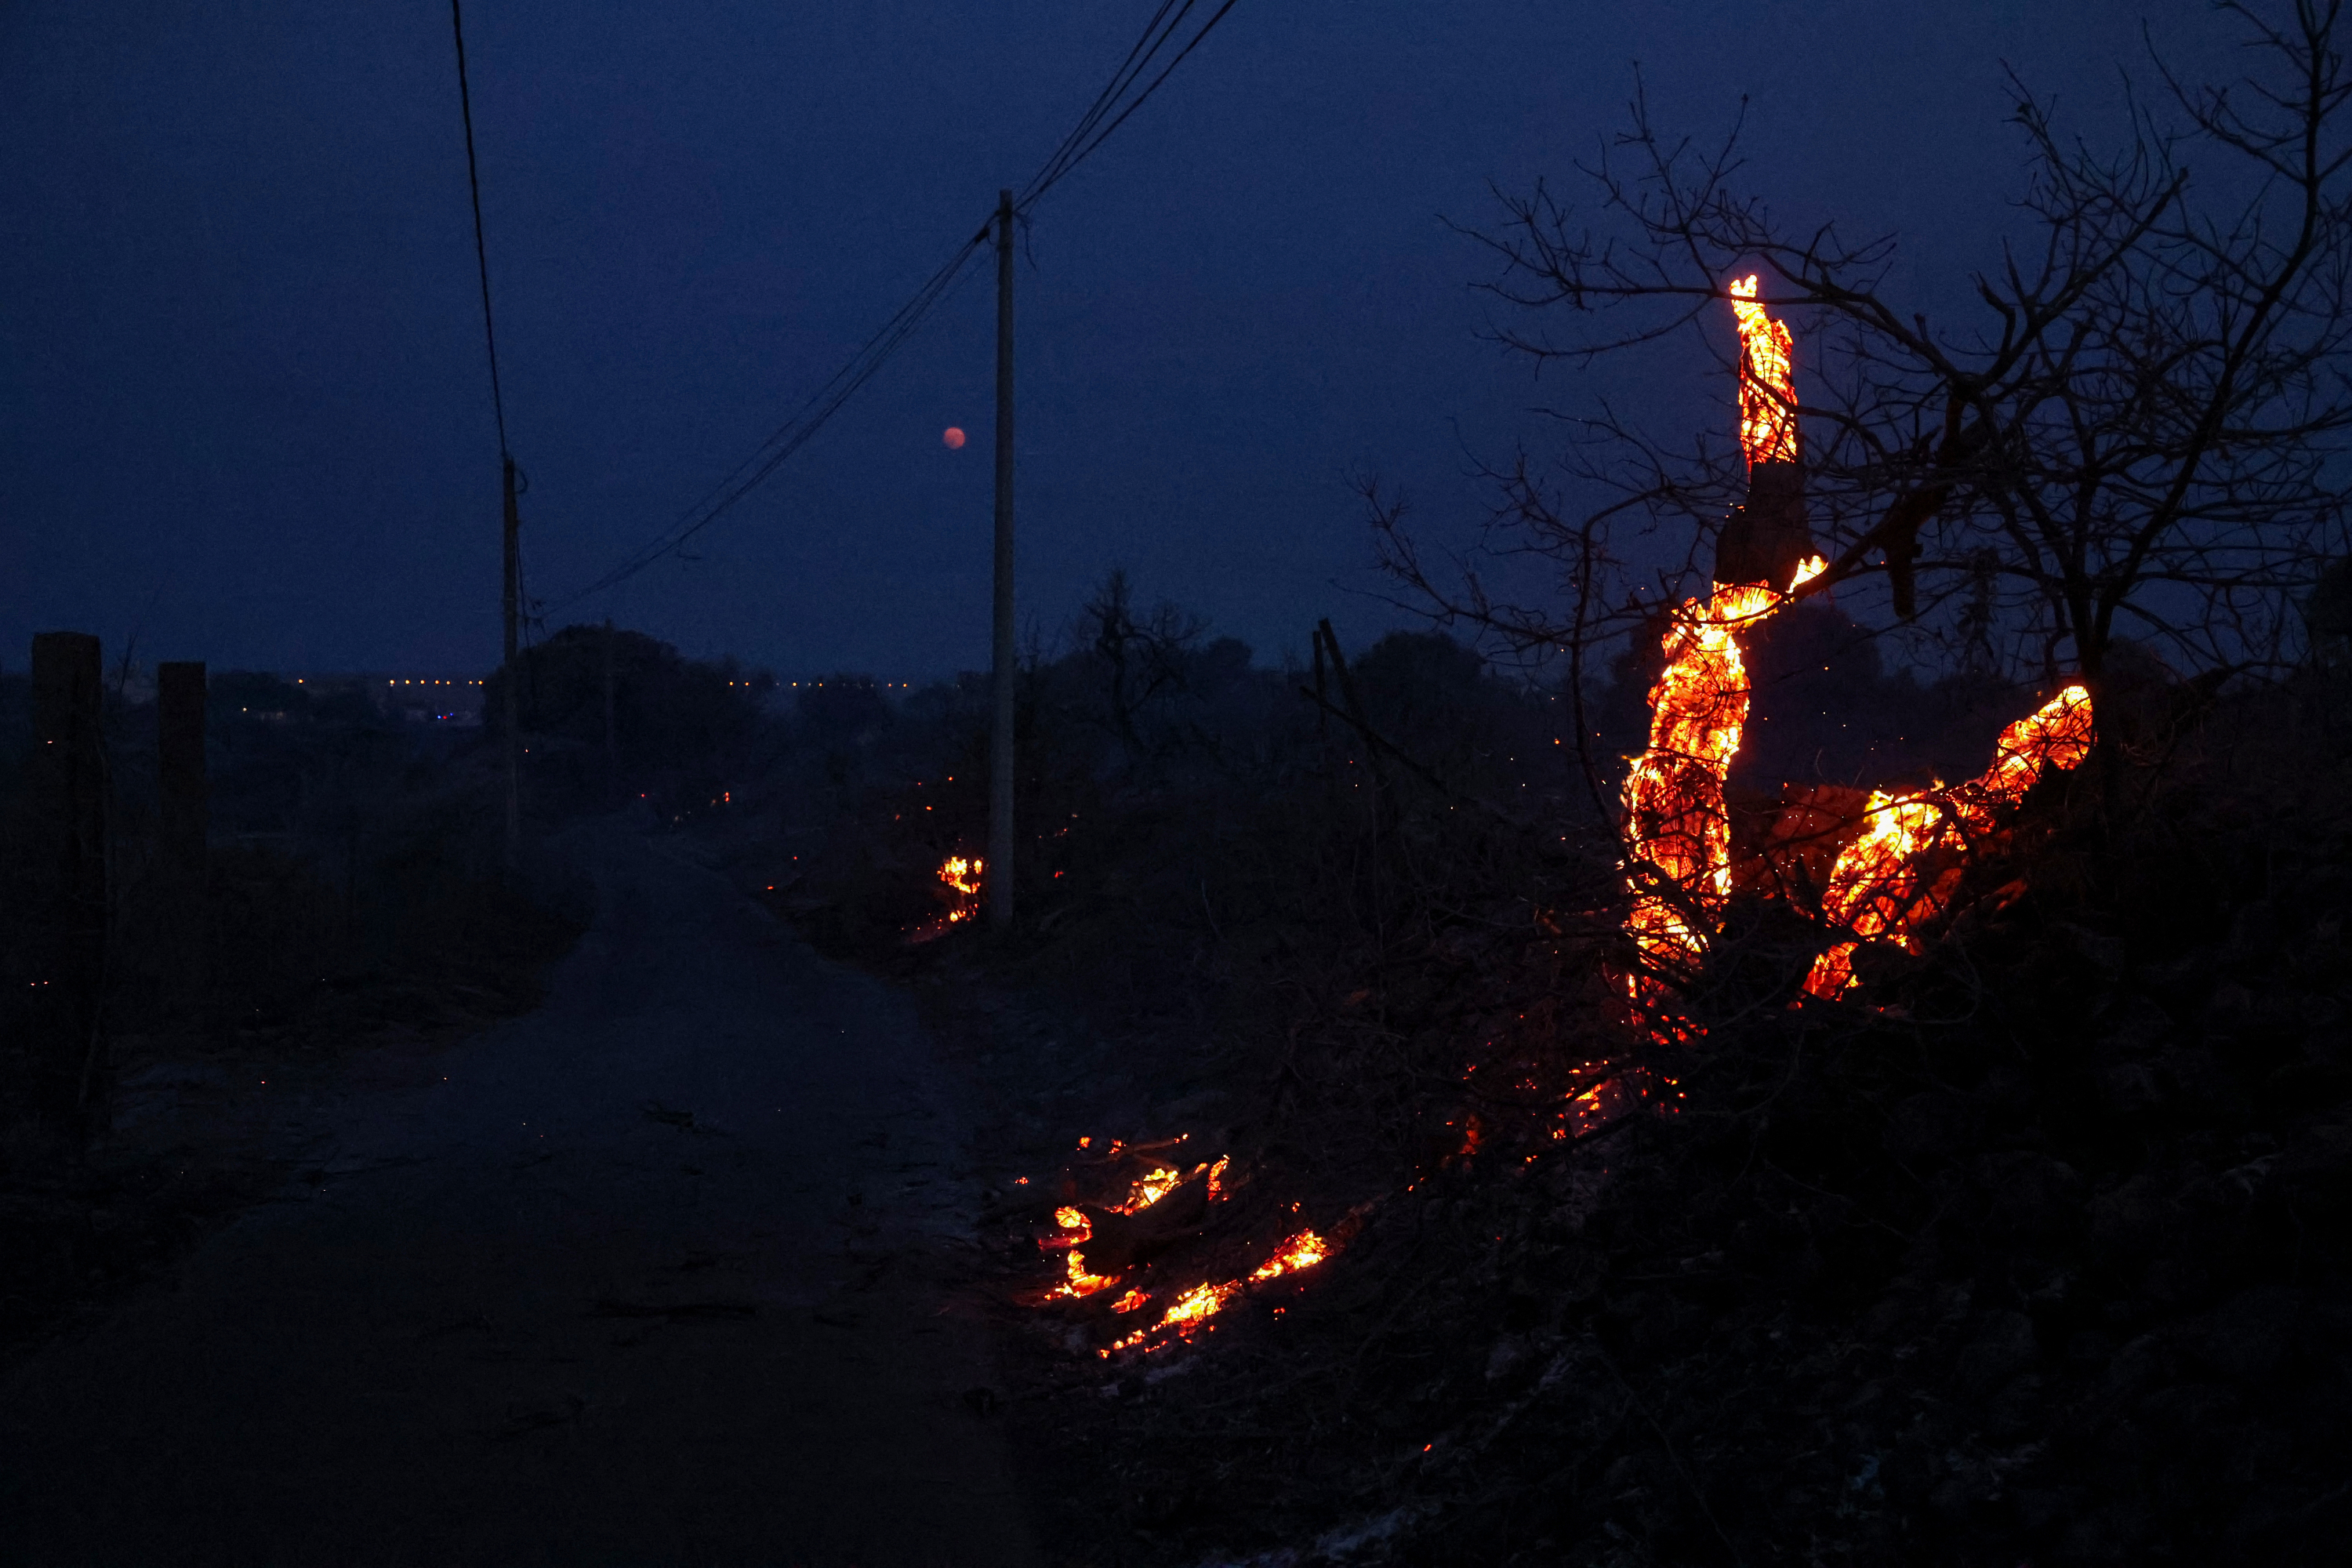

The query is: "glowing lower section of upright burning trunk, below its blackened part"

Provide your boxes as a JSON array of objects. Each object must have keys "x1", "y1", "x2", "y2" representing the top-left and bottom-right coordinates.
[{"x1": 1623, "y1": 555, "x2": 1825, "y2": 1001}]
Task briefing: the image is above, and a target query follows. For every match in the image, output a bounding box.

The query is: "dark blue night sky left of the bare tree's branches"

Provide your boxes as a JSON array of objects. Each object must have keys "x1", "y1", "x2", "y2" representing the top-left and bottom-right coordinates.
[{"x1": 0, "y1": 0, "x2": 2209, "y2": 680}]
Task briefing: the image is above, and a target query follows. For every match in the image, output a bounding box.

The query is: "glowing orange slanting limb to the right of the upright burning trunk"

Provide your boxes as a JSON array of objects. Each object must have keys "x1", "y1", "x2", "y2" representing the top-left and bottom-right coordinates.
[{"x1": 1804, "y1": 687, "x2": 2093, "y2": 996}]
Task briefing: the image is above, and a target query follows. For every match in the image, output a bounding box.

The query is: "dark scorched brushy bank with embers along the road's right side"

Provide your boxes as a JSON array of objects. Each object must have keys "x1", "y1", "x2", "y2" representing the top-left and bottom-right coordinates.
[{"x1": 757, "y1": 588, "x2": 2352, "y2": 1568}]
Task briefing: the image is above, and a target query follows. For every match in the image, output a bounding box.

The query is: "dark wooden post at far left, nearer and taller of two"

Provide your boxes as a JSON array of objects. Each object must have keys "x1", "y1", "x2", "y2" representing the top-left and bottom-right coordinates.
[{"x1": 26, "y1": 633, "x2": 108, "y2": 1140}]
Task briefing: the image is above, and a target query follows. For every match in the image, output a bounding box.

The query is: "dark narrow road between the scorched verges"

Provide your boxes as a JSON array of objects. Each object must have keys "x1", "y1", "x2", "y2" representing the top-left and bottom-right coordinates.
[{"x1": 0, "y1": 839, "x2": 1035, "y2": 1568}]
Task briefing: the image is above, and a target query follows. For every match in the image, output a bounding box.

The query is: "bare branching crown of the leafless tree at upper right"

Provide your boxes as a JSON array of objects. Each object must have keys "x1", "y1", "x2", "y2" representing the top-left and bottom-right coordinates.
[{"x1": 1376, "y1": 0, "x2": 2352, "y2": 710}]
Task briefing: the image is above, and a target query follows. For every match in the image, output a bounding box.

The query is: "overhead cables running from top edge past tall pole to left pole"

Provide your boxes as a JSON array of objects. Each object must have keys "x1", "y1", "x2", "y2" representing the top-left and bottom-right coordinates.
[{"x1": 550, "y1": 0, "x2": 1240, "y2": 612}]
